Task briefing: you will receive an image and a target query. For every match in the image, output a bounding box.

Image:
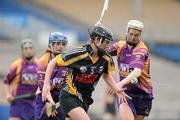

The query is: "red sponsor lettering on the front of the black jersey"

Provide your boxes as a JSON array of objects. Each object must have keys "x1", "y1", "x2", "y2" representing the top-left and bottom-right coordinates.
[{"x1": 75, "y1": 73, "x2": 99, "y2": 84}]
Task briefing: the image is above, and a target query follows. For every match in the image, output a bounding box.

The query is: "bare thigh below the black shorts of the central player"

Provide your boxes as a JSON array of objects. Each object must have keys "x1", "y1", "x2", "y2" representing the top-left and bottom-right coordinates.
[{"x1": 68, "y1": 107, "x2": 90, "y2": 120}]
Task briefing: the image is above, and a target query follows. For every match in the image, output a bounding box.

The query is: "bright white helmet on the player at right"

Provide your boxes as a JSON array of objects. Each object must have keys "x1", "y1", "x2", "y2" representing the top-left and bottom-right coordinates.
[{"x1": 127, "y1": 20, "x2": 144, "y2": 31}]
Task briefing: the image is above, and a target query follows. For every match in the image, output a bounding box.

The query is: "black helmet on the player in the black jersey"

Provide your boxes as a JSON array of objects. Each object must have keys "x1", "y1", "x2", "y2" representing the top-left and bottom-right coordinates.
[{"x1": 90, "y1": 26, "x2": 113, "y2": 41}]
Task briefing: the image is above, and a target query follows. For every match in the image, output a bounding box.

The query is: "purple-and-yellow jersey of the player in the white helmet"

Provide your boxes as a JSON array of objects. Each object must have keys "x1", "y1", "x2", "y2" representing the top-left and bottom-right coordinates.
[{"x1": 109, "y1": 41, "x2": 153, "y2": 94}]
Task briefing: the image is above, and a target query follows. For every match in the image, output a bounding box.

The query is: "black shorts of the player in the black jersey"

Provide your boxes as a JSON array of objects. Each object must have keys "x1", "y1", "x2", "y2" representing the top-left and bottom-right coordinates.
[{"x1": 60, "y1": 90, "x2": 89, "y2": 117}]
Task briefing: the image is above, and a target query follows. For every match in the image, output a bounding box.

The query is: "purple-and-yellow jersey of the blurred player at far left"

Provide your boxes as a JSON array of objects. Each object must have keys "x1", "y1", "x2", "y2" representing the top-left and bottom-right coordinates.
[{"x1": 4, "y1": 59, "x2": 38, "y2": 101}]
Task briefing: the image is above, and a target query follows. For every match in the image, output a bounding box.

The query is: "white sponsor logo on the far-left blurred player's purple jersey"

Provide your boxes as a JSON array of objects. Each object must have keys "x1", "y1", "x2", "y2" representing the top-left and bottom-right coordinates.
[{"x1": 22, "y1": 73, "x2": 38, "y2": 84}]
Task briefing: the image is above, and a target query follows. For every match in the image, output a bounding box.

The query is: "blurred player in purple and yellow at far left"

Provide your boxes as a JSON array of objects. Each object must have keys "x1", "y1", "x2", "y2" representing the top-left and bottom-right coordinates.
[{"x1": 4, "y1": 39, "x2": 38, "y2": 120}]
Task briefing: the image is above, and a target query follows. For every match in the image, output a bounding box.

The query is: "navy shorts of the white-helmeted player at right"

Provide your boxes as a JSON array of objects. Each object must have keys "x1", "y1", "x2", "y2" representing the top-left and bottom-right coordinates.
[{"x1": 117, "y1": 93, "x2": 153, "y2": 116}]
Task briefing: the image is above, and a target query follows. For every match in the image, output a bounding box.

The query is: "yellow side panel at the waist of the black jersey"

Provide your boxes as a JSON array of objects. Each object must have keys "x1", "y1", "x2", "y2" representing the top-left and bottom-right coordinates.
[{"x1": 67, "y1": 73, "x2": 77, "y2": 96}]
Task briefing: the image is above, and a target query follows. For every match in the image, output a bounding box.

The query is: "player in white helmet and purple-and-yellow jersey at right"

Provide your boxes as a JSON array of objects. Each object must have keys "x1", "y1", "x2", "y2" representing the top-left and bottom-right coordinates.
[{"x1": 108, "y1": 20, "x2": 153, "y2": 120}]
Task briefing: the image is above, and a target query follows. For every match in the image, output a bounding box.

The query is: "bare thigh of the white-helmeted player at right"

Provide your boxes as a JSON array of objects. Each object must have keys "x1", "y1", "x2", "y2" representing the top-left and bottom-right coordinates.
[{"x1": 119, "y1": 103, "x2": 134, "y2": 120}]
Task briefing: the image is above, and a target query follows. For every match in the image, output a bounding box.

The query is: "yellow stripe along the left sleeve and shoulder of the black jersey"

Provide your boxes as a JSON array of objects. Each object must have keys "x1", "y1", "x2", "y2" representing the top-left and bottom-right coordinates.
[{"x1": 56, "y1": 53, "x2": 89, "y2": 66}]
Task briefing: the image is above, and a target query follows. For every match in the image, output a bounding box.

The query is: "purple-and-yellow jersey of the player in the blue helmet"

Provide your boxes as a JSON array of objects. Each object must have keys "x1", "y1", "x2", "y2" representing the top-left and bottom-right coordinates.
[{"x1": 38, "y1": 52, "x2": 67, "y2": 98}]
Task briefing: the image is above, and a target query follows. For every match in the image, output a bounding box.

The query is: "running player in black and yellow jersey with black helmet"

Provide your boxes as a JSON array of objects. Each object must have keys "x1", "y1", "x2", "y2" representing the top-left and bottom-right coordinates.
[{"x1": 42, "y1": 26, "x2": 129, "y2": 120}]
